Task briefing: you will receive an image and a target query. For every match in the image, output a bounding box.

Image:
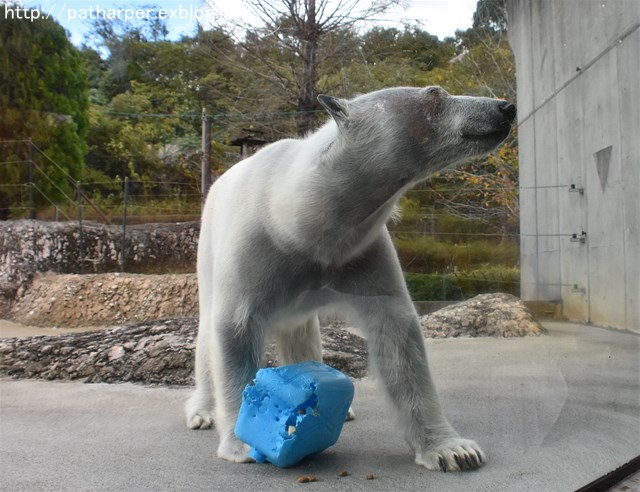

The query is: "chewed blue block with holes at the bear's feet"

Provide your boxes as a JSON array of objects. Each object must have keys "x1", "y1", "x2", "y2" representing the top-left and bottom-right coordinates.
[{"x1": 235, "y1": 361, "x2": 353, "y2": 468}]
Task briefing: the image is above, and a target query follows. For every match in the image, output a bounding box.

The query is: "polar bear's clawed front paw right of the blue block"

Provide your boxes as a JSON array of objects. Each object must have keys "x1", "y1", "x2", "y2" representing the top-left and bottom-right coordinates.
[{"x1": 416, "y1": 438, "x2": 487, "y2": 473}]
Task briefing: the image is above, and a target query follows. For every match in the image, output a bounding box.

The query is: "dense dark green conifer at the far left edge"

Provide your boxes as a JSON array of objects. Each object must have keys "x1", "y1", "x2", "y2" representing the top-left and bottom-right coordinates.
[{"x1": 0, "y1": 5, "x2": 88, "y2": 218}]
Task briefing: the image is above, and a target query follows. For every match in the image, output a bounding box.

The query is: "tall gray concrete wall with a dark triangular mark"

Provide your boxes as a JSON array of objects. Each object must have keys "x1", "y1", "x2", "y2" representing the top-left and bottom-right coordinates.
[{"x1": 507, "y1": 0, "x2": 640, "y2": 331}]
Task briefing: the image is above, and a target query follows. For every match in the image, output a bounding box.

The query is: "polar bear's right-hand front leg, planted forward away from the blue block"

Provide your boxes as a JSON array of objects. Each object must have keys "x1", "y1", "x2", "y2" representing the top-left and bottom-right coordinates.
[{"x1": 338, "y1": 236, "x2": 486, "y2": 471}]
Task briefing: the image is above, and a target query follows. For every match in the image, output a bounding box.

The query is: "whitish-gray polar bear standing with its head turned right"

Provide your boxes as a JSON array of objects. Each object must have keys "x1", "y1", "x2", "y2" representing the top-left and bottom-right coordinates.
[{"x1": 186, "y1": 87, "x2": 516, "y2": 471}]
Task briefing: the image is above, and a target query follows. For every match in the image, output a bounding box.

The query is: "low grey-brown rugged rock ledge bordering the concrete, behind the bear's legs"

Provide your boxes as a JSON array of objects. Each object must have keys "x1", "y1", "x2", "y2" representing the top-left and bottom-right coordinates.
[{"x1": 0, "y1": 318, "x2": 368, "y2": 385}]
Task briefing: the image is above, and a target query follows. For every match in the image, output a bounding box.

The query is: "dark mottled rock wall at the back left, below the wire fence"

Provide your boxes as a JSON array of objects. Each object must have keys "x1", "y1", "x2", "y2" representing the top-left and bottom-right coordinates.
[{"x1": 0, "y1": 220, "x2": 200, "y2": 298}]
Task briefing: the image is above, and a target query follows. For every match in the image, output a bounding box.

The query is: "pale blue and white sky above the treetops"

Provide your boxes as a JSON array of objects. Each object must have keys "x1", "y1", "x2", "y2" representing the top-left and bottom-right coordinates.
[{"x1": 11, "y1": 0, "x2": 476, "y2": 46}]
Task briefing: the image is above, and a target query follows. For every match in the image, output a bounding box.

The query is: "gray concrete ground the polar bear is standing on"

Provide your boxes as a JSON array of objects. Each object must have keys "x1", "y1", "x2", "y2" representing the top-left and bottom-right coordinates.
[{"x1": 0, "y1": 323, "x2": 640, "y2": 492}]
